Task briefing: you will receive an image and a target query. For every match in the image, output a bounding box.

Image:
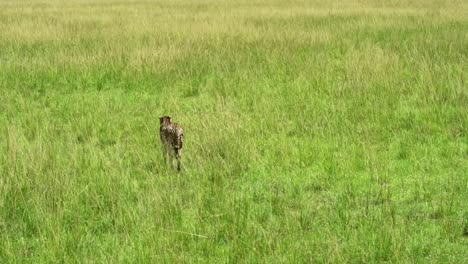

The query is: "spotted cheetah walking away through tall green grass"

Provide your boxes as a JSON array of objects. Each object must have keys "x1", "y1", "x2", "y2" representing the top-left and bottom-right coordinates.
[{"x1": 159, "y1": 116, "x2": 184, "y2": 171}]
